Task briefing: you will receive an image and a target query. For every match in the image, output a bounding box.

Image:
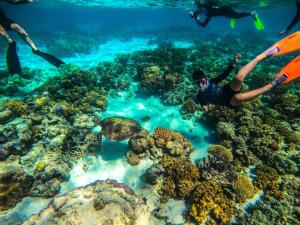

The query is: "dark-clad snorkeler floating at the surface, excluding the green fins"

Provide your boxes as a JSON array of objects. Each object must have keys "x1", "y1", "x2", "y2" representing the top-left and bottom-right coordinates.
[{"x1": 190, "y1": 1, "x2": 257, "y2": 27}]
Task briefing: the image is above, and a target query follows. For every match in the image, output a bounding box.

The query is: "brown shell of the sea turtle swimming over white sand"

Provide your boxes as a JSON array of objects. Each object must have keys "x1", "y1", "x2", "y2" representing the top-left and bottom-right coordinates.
[{"x1": 101, "y1": 117, "x2": 143, "y2": 141}]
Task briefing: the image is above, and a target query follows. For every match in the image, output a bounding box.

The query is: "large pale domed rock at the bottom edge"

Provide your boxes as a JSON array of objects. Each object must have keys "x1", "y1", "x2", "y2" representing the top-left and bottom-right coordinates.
[{"x1": 23, "y1": 180, "x2": 150, "y2": 225}]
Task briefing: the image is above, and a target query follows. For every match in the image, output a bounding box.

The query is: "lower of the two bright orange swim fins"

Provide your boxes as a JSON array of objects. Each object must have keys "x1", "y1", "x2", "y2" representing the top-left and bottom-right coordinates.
[{"x1": 275, "y1": 56, "x2": 300, "y2": 84}]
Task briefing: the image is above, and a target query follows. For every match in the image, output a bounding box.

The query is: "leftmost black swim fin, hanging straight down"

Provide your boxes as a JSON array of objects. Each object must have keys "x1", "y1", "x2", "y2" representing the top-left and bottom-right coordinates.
[{"x1": 6, "y1": 41, "x2": 22, "y2": 74}]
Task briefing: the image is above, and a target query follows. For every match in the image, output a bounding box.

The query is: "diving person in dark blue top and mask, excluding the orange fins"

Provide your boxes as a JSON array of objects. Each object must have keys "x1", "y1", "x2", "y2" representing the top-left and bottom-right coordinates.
[{"x1": 193, "y1": 47, "x2": 287, "y2": 111}]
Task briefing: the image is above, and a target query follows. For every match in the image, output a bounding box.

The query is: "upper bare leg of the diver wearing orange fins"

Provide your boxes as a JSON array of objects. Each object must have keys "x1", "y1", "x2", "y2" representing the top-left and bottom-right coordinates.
[{"x1": 230, "y1": 53, "x2": 267, "y2": 91}]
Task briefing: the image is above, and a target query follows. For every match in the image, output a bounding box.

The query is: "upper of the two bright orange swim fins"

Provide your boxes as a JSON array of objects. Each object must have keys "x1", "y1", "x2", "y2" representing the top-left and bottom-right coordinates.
[{"x1": 272, "y1": 31, "x2": 300, "y2": 56}]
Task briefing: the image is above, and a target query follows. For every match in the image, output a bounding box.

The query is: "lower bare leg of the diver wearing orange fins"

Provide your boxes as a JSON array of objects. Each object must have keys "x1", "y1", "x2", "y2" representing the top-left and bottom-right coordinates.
[{"x1": 230, "y1": 84, "x2": 273, "y2": 106}]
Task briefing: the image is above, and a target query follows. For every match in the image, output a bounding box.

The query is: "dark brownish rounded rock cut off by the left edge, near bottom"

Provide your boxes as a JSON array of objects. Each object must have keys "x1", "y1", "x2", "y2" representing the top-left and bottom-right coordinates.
[{"x1": 0, "y1": 162, "x2": 33, "y2": 212}]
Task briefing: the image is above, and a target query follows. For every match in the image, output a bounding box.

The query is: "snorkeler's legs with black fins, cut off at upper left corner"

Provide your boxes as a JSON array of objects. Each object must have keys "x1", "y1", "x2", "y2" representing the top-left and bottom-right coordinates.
[{"x1": 0, "y1": 0, "x2": 64, "y2": 74}]
